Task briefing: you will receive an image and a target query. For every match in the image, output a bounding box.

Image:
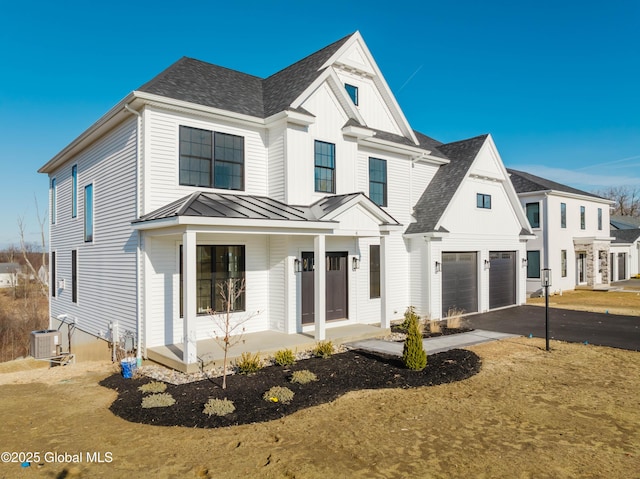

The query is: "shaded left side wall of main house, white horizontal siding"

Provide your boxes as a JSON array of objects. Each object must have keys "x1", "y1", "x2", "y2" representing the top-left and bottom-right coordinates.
[{"x1": 50, "y1": 119, "x2": 138, "y2": 336}]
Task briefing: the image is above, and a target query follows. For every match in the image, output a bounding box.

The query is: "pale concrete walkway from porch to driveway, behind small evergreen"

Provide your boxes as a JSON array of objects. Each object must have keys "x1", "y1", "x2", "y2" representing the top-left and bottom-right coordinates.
[{"x1": 346, "y1": 329, "x2": 520, "y2": 356}]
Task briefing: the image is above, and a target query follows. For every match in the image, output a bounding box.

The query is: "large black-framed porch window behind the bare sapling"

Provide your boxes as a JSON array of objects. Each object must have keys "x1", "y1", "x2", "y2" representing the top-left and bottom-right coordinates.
[{"x1": 180, "y1": 245, "x2": 245, "y2": 314}]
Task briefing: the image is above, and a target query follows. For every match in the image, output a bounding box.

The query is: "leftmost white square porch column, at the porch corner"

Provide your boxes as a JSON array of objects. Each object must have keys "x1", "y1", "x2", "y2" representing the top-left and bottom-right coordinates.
[{"x1": 182, "y1": 230, "x2": 198, "y2": 364}]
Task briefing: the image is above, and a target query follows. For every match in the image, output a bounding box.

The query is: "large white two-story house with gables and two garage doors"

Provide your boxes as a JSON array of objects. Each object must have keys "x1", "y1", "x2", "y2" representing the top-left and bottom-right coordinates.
[{"x1": 39, "y1": 32, "x2": 533, "y2": 367}]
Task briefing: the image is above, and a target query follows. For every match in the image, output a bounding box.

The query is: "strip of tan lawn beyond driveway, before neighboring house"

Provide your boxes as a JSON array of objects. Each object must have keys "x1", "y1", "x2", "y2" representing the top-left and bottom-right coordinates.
[{"x1": 527, "y1": 290, "x2": 640, "y2": 316}]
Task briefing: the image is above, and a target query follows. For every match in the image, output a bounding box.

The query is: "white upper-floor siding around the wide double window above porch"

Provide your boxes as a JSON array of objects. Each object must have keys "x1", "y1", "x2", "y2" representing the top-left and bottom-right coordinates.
[{"x1": 141, "y1": 107, "x2": 269, "y2": 214}]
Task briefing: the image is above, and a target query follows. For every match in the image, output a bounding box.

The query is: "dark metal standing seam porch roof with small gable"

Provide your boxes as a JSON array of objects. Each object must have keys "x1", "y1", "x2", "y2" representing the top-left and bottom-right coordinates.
[{"x1": 132, "y1": 191, "x2": 400, "y2": 226}]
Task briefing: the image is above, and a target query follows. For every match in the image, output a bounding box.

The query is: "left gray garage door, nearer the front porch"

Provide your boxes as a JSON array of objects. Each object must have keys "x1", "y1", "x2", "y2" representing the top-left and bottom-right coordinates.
[{"x1": 442, "y1": 252, "x2": 478, "y2": 317}]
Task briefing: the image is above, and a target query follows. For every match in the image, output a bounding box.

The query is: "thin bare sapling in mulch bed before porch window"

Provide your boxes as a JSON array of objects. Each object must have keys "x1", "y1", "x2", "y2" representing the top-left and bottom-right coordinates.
[{"x1": 209, "y1": 278, "x2": 253, "y2": 389}]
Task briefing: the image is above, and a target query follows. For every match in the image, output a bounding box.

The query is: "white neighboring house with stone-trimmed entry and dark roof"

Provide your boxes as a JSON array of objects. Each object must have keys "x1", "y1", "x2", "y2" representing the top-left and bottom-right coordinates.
[{"x1": 508, "y1": 169, "x2": 613, "y2": 293}]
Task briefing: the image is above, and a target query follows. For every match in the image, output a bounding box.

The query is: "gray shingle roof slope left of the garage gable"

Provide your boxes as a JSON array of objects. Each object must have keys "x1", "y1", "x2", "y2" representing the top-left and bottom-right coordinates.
[{"x1": 405, "y1": 135, "x2": 488, "y2": 234}]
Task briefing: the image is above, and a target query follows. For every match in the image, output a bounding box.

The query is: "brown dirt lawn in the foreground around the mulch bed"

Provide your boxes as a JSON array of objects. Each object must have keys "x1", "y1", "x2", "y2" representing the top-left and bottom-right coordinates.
[{"x1": 0, "y1": 338, "x2": 640, "y2": 478}]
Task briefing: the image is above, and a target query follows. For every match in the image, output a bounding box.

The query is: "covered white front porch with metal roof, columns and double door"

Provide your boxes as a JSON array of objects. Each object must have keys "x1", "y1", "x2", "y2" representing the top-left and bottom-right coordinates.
[{"x1": 135, "y1": 193, "x2": 400, "y2": 371}]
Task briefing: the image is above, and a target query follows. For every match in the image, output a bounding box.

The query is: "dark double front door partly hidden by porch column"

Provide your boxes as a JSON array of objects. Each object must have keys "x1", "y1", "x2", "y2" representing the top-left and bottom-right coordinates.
[{"x1": 301, "y1": 252, "x2": 348, "y2": 324}]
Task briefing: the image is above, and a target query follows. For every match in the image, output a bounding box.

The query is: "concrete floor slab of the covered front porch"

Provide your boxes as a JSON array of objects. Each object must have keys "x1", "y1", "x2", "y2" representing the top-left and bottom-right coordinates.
[{"x1": 147, "y1": 324, "x2": 390, "y2": 373}]
